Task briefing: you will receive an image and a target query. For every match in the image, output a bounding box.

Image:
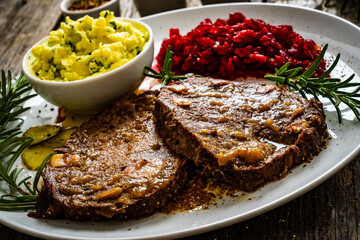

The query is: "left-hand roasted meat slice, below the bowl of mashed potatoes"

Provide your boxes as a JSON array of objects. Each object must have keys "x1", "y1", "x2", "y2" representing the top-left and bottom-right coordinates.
[{"x1": 37, "y1": 92, "x2": 187, "y2": 220}]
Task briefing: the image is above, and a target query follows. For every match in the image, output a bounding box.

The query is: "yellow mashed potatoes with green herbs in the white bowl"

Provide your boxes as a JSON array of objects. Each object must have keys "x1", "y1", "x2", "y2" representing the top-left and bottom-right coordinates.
[{"x1": 27, "y1": 11, "x2": 149, "y2": 81}]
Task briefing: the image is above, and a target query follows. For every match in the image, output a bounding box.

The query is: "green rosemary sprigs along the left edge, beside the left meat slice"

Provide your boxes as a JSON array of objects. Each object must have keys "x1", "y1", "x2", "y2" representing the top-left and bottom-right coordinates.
[{"x1": 0, "y1": 70, "x2": 50, "y2": 211}]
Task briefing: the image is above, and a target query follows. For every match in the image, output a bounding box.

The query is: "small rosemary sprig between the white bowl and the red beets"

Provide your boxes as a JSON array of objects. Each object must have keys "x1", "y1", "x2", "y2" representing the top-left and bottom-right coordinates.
[{"x1": 143, "y1": 45, "x2": 194, "y2": 85}]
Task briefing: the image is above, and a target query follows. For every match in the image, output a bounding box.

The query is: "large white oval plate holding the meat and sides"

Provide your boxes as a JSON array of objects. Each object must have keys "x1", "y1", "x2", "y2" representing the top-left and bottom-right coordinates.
[{"x1": 0, "y1": 3, "x2": 360, "y2": 239}]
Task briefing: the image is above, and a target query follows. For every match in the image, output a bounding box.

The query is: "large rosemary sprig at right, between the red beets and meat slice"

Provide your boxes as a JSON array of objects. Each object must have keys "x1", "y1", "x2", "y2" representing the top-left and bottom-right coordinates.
[{"x1": 265, "y1": 44, "x2": 360, "y2": 123}]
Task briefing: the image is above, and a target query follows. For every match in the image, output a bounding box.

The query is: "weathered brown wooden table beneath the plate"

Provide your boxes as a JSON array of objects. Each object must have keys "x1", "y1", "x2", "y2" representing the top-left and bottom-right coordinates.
[{"x1": 0, "y1": 0, "x2": 360, "y2": 240}]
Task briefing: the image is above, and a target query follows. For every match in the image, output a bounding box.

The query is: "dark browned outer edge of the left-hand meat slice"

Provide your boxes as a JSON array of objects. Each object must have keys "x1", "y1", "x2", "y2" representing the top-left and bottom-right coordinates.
[{"x1": 36, "y1": 93, "x2": 188, "y2": 221}]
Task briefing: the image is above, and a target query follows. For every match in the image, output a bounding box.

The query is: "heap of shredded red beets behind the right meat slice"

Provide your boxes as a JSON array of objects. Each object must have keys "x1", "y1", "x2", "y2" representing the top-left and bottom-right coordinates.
[{"x1": 154, "y1": 12, "x2": 325, "y2": 79}]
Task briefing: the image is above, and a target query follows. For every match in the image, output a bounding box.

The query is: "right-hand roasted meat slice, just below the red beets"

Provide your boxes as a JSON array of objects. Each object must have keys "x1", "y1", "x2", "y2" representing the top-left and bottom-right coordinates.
[{"x1": 154, "y1": 78, "x2": 327, "y2": 191}]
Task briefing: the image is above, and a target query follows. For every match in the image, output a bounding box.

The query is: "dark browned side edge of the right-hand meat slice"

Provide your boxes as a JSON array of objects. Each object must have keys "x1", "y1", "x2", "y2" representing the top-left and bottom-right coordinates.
[{"x1": 154, "y1": 79, "x2": 327, "y2": 192}]
